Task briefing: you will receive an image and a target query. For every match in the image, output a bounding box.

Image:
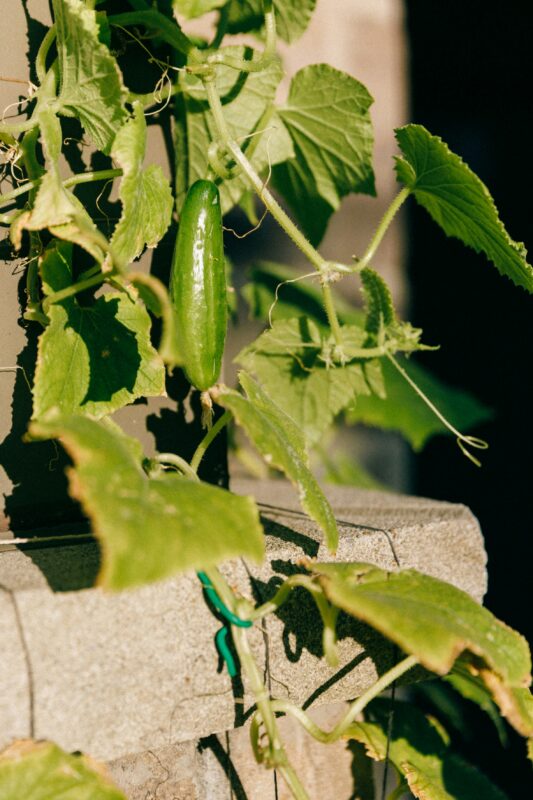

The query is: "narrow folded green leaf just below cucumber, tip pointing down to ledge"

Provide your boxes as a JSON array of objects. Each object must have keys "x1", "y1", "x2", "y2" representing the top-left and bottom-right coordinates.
[{"x1": 217, "y1": 373, "x2": 338, "y2": 550}]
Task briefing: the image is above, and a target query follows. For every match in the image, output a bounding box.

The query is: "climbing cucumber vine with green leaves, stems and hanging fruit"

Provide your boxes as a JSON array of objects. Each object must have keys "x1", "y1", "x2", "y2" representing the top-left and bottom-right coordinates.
[{"x1": 0, "y1": 0, "x2": 533, "y2": 800}]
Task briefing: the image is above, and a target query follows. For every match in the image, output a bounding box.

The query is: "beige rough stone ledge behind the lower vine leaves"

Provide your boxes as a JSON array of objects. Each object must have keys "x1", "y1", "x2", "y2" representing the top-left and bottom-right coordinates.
[{"x1": 0, "y1": 481, "x2": 486, "y2": 761}]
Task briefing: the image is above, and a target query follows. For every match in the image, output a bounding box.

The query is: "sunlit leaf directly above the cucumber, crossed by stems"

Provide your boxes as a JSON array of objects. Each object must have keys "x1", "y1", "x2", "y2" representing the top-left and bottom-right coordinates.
[{"x1": 177, "y1": 46, "x2": 292, "y2": 214}]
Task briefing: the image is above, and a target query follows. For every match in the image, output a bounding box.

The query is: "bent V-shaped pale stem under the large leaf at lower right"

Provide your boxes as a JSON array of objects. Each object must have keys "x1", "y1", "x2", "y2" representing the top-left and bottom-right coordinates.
[{"x1": 271, "y1": 656, "x2": 418, "y2": 744}]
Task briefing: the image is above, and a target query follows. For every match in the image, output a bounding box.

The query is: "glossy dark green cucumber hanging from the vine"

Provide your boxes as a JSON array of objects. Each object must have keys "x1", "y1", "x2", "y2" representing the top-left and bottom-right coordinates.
[{"x1": 170, "y1": 180, "x2": 227, "y2": 392}]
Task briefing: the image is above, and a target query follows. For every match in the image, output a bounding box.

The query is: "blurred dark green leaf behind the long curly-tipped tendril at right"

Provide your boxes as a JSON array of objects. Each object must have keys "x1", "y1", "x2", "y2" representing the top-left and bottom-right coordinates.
[{"x1": 347, "y1": 359, "x2": 493, "y2": 450}]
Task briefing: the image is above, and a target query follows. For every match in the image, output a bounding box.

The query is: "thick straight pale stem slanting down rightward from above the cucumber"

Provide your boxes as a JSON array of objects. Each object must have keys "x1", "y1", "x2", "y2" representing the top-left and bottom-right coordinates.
[{"x1": 204, "y1": 77, "x2": 328, "y2": 272}]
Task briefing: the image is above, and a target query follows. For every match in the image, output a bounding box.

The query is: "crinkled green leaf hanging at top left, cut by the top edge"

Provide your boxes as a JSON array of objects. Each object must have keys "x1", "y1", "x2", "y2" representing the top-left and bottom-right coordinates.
[{"x1": 52, "y1": 0, "x2": 128, "y2": 153}]
